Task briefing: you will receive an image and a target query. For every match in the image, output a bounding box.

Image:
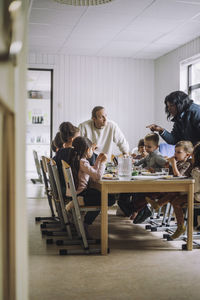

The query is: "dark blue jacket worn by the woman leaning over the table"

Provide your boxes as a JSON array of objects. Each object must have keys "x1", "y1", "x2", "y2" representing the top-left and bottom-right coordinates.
[{"x1": 160, "y1": 103, "x2": 200, "y2": 145}]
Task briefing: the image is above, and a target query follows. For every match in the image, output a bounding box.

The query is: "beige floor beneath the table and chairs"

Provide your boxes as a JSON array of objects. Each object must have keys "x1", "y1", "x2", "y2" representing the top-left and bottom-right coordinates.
[{"x1": 27, "y1": 184, "x2": 200, "y2": 300}]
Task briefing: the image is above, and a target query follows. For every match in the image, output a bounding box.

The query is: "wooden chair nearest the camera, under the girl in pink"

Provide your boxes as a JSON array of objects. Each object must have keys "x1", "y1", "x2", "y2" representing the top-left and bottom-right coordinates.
[{"x1": 60, "y1": 161, "x2": 101, "y2": 255}]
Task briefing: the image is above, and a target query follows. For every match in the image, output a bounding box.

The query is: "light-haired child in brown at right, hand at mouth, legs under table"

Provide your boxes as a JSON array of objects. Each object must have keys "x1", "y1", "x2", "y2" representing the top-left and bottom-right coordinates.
[{"x1": 146, "y1": 141, "x2": 195, "y2": 239}]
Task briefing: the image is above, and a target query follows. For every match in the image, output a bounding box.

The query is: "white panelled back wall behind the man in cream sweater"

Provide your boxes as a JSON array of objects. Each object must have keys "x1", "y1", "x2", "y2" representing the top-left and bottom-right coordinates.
[{"x1": 28, "y1": 53, "x2": 154, "y2": 151}]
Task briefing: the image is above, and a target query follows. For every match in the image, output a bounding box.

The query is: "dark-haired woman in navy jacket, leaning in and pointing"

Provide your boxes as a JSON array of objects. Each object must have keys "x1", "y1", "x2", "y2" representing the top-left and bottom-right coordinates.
[{"x1": 147, "y1": 91, "x2": 200, "y2": 145}]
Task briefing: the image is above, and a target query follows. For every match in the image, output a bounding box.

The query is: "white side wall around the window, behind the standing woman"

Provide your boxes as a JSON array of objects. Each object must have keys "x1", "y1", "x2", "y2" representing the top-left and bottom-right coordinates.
[{"x1": 155, "y1": 37, "x2": 200, "y2": 129}]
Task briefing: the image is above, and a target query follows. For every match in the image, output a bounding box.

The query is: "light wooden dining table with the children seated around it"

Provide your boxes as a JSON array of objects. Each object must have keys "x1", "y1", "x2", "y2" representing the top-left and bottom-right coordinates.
[{"x1": 94, "y1": 177, "x2": 194, "y2": 255}]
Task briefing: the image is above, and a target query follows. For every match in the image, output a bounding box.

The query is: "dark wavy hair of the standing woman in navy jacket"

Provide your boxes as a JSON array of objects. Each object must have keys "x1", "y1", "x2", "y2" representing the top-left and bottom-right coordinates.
[{"x1": 165, "y1": 91, "x2": 193, "y2": 119}]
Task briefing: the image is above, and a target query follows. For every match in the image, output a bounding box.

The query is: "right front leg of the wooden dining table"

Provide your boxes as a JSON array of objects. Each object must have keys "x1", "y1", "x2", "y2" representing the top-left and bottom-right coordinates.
[{"x1": 187, "y1": 184, "x2": 194, "y2": 250}]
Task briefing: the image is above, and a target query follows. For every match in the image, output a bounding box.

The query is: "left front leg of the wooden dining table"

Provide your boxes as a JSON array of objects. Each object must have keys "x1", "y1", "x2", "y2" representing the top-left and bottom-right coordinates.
[{"x1": 101, "y1": 187, "x2": 108, "y2": 255}]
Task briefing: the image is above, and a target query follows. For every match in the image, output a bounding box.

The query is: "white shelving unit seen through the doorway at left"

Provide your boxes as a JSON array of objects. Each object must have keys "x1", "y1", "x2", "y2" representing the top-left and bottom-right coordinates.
[{"x1": 26, "y1": 70, "x2": 52, "y2": 173}]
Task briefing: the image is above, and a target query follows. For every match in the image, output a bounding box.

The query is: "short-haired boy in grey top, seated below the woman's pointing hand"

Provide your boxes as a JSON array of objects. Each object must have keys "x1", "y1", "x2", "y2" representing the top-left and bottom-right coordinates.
[{"x1": 118, "y1": 133, "x2": 167, "y2": 219}]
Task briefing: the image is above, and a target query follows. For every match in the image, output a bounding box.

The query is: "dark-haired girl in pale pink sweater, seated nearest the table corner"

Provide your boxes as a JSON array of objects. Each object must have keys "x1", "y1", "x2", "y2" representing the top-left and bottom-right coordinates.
[{"x1": 69, "y1": 136, "x2": 115, "y2": 235}]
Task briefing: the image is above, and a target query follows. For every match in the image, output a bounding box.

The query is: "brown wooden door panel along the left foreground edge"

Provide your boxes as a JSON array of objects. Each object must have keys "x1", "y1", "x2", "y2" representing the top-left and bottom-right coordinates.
[{"x1": 0, "y1": 99, "x2": 16, "y2": 300}]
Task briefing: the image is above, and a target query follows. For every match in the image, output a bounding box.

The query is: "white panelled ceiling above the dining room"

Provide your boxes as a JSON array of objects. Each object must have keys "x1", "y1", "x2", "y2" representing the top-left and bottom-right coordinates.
[{"x1": 29, "y1": 0, "x2": 200, "y2": 59}]
